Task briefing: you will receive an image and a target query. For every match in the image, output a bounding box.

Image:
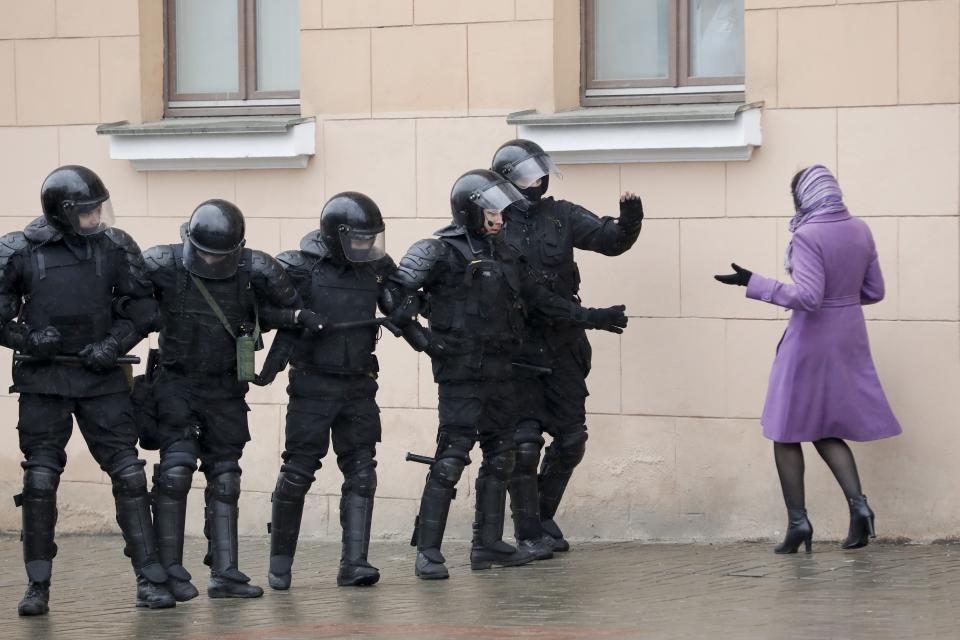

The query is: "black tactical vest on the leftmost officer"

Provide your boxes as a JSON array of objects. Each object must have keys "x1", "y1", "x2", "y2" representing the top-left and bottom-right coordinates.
[{"x1": 20, "y1": 238, "x2": 116, "y2": 354}]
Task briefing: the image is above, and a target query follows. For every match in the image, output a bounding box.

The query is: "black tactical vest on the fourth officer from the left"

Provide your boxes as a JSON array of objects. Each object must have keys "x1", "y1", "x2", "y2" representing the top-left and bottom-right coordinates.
[{"x1": 429, "y1": 237, "x2": 523, "y2": 353}]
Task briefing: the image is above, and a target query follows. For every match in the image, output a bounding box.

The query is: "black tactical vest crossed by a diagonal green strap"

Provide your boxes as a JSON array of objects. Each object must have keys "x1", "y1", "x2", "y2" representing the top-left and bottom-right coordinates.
[{"x1": 160, "y1": 245, "x2": 256, "y2": 375}]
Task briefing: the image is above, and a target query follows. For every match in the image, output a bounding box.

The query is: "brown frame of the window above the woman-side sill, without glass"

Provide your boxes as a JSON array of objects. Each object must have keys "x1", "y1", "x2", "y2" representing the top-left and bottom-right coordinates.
[{"x1": 580, "y1": 0, "x2": 745, "y2": 107}]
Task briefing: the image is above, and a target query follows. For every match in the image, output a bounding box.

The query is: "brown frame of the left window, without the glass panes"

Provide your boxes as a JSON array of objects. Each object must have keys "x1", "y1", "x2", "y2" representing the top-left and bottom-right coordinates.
[{"x1": 163, "y1": 0, "x2": 300, "y2": 116}]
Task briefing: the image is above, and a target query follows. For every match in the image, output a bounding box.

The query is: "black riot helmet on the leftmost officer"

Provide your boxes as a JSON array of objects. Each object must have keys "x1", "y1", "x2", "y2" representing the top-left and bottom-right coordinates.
[{"x1": 40, "y1": 164, "x2": 113, "y2": 236}]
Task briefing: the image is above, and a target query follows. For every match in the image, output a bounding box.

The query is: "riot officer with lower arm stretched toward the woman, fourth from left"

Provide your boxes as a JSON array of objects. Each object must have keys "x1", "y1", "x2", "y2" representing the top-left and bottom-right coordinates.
[{"x1": 391, "y1": 169, "x2": 626, "y2": 579}]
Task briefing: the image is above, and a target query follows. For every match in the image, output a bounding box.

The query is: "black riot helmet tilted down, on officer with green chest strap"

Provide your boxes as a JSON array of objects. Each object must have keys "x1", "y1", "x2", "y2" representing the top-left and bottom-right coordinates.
[{"x1": 180, "y1": 199, "x2": 246, "y2": 280}]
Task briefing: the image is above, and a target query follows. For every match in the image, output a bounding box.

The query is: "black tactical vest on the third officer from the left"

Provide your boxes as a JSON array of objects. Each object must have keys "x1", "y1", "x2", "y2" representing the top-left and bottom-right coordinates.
[{"x1": 291, "y1": 259, "x2": 380, "y2": 374}]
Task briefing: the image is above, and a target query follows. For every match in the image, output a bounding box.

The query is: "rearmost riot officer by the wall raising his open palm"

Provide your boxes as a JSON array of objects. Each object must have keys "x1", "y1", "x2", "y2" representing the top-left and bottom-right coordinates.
[{"x1": 491, "y1": 140, "x2": 643, "y2": 558}]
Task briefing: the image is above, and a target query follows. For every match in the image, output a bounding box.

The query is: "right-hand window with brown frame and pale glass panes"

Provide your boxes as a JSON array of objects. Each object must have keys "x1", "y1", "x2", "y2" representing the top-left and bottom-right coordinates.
[{"x1": 581, "y1": 0, "x2": 744, "y2": 106}]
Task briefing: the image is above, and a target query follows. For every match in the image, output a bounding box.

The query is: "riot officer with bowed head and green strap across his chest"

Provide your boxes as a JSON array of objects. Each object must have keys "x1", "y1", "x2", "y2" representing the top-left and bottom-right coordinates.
[{"x1": 141, "y1": 199, "x2": 297, "y2": 601}]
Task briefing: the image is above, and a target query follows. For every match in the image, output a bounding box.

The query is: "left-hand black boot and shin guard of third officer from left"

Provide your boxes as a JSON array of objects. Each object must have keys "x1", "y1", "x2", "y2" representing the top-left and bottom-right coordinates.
[{"x1": 267, "y1": 471, "x2": 313, "y2": 591}]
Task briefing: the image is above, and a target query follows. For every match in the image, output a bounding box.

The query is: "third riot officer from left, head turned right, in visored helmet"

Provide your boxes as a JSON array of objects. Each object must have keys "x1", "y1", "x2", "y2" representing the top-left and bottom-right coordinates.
[{"x1": 258, "y1": 191, "x2": 404, "y2": 590}]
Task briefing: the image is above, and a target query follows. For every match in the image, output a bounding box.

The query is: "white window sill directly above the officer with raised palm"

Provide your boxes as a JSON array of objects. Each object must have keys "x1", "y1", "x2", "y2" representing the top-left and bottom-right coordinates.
[{"x1": 507, "y1": 103, "x2": 763, "y2": 164}]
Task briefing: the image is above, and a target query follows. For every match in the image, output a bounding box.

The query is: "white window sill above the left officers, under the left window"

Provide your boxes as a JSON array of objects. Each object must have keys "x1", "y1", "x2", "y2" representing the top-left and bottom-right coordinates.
[{"x1": 97, "y1": 116, "x2": 316, "y2": 171}]
